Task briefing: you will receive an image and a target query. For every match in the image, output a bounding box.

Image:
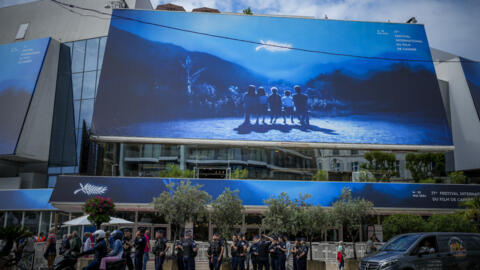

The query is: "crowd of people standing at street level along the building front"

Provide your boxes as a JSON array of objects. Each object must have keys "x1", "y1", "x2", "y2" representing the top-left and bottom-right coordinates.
[{"x1": 20, "y1": 229, "x2": 378, "y2": 270}]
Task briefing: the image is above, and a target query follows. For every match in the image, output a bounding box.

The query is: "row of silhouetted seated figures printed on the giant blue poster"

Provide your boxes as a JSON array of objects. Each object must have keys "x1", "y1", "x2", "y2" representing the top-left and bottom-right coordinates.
[{"x1": 242, "y1": 85, "x2": 309, "y2": 126}]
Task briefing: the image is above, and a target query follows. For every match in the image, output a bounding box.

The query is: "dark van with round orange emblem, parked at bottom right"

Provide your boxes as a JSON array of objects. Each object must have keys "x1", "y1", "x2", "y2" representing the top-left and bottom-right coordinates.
[{"x1": 358, "y1": 233, "x2": 480, "y2": 270}]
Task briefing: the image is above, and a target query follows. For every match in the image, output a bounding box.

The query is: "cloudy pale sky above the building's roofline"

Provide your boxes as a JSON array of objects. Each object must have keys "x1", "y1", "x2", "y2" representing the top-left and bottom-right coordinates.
[{"x1": 151, "y1": 0, "x2": 480, "y2": 60}]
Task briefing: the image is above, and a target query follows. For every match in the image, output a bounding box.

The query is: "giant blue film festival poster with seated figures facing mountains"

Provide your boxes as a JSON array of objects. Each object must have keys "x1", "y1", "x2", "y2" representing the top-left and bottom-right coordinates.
[{"x1": 92, "y1": 10, "x2": 452, "y2": 146}]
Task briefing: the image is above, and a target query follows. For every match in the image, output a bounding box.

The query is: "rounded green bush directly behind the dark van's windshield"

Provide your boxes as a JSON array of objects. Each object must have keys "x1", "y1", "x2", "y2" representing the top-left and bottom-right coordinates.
[{"x1": 382, "y1": 214, "x2": 426, "y2": 240}]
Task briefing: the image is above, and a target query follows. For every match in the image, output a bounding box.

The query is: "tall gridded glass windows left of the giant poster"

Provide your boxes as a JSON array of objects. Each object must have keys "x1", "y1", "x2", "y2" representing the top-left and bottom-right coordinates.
[{"x1": 48, "y1": 37, "x2": 107, "y2": 184}]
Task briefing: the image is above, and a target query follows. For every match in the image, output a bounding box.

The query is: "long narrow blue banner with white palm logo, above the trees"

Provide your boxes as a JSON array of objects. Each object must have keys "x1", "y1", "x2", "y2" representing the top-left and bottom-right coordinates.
[{"x1": 50, "y1": 176, "x2": 480, "y2": 209}]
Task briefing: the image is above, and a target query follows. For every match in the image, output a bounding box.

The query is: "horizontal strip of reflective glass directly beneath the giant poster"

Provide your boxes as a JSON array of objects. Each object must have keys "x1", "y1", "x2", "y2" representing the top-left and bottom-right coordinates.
[{"x1": 96, "y1": 143, "x2": 420, "y2": 181}]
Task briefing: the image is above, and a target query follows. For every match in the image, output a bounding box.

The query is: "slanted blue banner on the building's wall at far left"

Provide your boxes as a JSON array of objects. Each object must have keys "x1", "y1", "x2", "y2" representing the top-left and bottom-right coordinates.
[{"x1": 0, "y1": 38, "x2": 50, "y2": 155}]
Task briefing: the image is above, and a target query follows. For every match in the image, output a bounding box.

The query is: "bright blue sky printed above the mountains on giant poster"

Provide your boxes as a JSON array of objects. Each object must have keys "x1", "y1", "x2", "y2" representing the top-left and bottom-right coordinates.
[{"x1": 112, "y1": 10, "x2": 433, "y2": 83}]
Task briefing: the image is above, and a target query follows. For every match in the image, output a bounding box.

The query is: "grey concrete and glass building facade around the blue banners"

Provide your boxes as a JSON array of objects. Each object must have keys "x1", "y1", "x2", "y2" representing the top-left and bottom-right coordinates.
[{"x1": 0, "y1": 0, "x2": 480, "y2": 243}]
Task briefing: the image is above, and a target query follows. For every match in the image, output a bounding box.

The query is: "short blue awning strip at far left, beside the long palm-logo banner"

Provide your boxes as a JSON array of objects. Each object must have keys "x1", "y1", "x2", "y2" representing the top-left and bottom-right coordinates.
[{"x1": 0, "y1": 188, "x2": 57, "y2": 211}]
